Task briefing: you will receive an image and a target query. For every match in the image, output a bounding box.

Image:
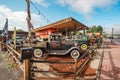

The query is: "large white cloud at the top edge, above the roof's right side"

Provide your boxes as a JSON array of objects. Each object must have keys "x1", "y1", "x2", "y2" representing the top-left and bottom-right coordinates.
[{"x1": 59, "y1": 0, "x2": 118, "y2": 16}]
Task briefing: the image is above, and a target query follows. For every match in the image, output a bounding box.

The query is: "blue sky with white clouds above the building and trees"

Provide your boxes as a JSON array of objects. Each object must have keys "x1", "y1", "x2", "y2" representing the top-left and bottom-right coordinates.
[{"x1": 0, "y1": 0, "x2": 120, "y2": 33}]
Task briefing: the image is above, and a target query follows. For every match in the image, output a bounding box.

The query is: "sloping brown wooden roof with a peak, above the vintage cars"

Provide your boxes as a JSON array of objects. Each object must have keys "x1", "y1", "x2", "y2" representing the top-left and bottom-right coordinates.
[{"x1": 35, "y1": 17, "x2": 88, "y2": 32}]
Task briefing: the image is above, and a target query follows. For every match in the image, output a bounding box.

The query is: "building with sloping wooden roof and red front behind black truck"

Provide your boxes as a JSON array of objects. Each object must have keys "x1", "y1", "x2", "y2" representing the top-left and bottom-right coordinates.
[{"x1": 34, "y1": 17, "x2": 88, "y2": 38}]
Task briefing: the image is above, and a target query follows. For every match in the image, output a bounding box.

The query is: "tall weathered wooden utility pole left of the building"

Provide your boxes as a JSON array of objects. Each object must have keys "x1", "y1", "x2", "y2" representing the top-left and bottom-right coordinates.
[{"x1": 26, "y1": 0, "x2": 32, "y2": 46}]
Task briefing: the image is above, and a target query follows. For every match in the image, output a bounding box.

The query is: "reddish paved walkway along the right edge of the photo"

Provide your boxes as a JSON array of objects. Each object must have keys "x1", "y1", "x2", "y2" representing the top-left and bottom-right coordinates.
[{"x1": 100, "y1": 40, "x2": 120, "y2": 80}]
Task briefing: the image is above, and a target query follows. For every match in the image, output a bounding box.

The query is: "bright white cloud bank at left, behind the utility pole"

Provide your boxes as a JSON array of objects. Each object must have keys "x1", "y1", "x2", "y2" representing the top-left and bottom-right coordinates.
[{"x1": 0, "y1": 5, "x2": 41, "y2": 31}]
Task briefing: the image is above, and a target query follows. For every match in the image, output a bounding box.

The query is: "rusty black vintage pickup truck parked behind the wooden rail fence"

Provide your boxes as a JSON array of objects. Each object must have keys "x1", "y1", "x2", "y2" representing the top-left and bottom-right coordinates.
[{"x1": 33, "y1": 34, "x2": 87, "y2": 58}]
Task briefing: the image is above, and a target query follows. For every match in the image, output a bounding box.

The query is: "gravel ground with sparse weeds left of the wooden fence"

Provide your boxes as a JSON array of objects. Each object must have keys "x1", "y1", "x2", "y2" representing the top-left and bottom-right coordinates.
[{"x1": 0, "y1": 52, "x2": 23, "y2": 80}]
